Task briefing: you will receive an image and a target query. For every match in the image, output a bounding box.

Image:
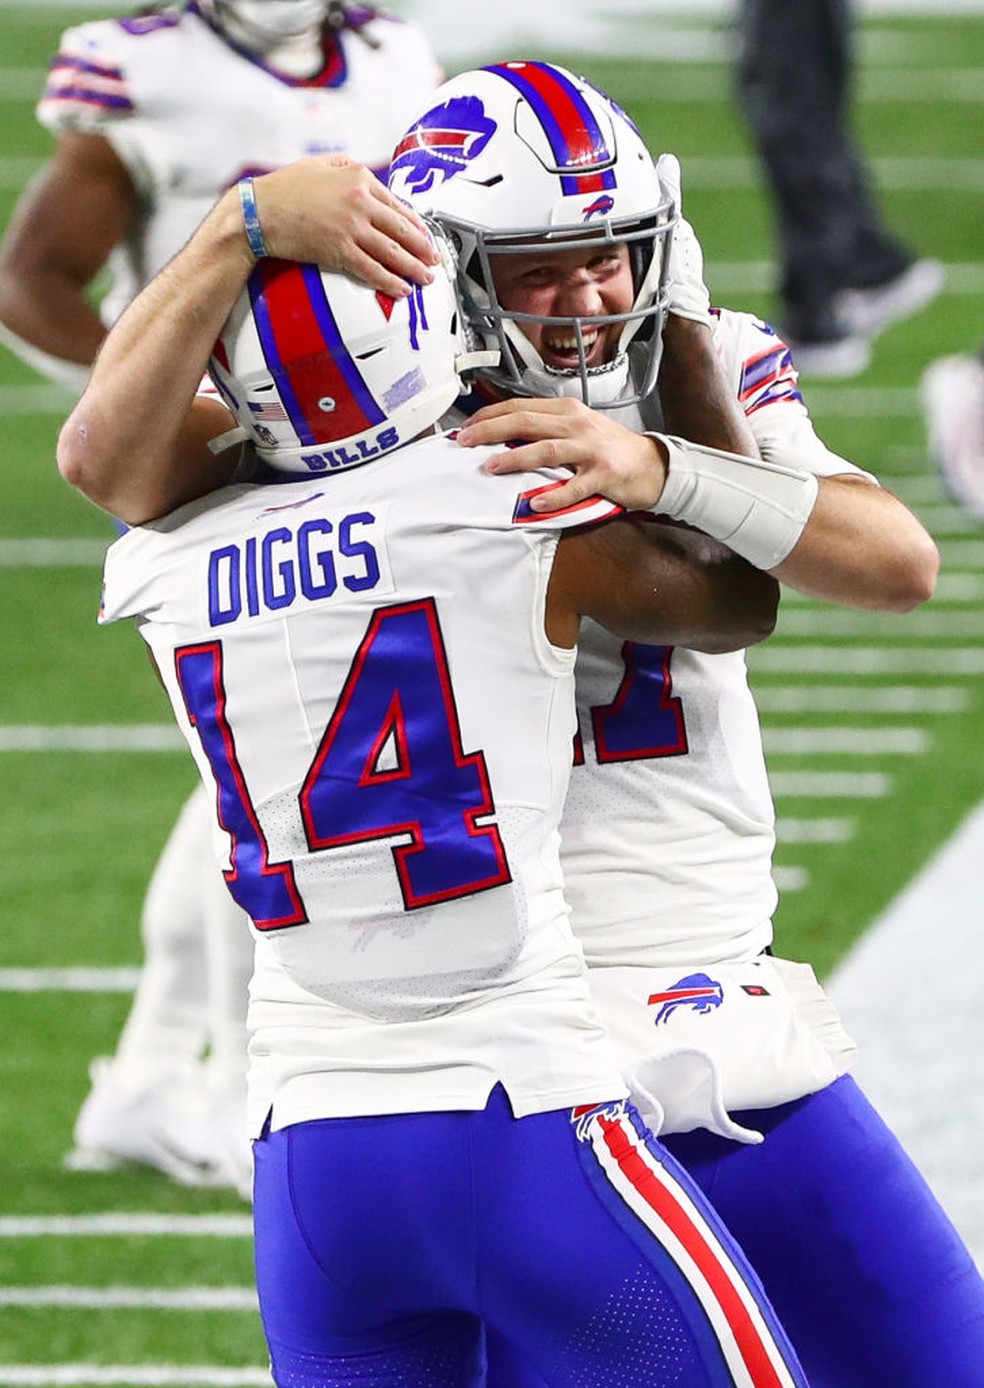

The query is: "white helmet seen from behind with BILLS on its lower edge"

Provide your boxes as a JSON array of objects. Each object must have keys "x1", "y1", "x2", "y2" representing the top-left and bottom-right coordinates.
[{"x1": 208, "y1": 235, "x2": 472, "y2": 473}]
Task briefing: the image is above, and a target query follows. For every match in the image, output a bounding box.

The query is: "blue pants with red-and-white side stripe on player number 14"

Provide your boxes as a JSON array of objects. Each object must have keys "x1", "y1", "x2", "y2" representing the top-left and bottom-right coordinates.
[{"x1": 254, "y1": 1088, "x2": 806, "y2": 1388}]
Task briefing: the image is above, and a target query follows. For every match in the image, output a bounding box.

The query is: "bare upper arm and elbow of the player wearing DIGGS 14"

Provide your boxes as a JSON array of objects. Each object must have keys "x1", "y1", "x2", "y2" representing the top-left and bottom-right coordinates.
[{"x1": 547, "y1": 516, "x2": 779, "y2": 652}]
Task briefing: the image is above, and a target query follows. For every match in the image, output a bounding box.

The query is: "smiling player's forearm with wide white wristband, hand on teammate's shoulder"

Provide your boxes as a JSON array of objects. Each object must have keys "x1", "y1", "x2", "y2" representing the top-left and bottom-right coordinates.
[{"x1": 458, "y1": 400, "x2": 940, "y2": 612}]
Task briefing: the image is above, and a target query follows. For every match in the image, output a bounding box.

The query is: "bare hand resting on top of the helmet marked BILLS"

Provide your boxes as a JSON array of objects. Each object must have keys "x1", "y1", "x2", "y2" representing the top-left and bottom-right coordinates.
[{"x1": 247, "y1": 154, "x2": 439, "y2": 298}]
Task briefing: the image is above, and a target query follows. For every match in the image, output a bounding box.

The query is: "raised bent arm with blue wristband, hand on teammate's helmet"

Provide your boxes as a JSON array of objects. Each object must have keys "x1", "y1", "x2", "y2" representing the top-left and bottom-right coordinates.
[{"x1": 57, "y1": 157, "x2": 434, "y2": 525}]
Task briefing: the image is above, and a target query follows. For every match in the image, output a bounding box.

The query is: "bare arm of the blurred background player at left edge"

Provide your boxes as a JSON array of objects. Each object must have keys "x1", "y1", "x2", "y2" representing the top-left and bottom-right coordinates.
[{"x1": 0, "y1": 130, "x2": 139, "y2": 389}]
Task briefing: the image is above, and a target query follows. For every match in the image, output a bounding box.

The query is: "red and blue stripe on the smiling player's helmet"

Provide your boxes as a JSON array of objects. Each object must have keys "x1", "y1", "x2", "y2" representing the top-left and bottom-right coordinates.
[{"x1": 484, "y1": 62, "x2": 616, "y2": 196}]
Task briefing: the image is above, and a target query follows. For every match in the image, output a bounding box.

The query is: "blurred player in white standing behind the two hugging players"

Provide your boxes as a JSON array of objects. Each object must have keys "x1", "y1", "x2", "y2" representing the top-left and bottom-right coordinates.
[{"x1": 0, "y1": 0, "x2": 440, "y2": 1190}]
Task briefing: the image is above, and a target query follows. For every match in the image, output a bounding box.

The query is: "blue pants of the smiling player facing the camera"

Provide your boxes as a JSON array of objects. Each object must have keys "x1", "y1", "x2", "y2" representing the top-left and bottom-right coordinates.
[{"x1": 489, "y1": 1076, "x2": 984, "y2": 1388}]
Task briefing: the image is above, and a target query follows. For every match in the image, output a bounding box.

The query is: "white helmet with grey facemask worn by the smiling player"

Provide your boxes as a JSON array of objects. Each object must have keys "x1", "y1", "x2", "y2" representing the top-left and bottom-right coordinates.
[{"x1": 389, "y1": 61, "x2": 677, "y2": 408}]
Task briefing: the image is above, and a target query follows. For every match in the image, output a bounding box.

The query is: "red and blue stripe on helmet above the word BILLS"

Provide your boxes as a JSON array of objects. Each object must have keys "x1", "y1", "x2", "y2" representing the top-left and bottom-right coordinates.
[{"x1": 248, "y1": 260, "x2": 386, "y2": 447}]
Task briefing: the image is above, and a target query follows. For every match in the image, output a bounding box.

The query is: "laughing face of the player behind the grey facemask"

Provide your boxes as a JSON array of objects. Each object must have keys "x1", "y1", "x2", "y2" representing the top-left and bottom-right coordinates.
[{"x1": 491, "y1": 243, "x2": 636, "y2": 371}]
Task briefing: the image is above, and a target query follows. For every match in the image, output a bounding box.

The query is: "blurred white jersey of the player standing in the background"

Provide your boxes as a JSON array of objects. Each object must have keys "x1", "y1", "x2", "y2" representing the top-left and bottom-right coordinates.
[{"x1": 37, "y1": 4, "x2": 441, "y2": 323}]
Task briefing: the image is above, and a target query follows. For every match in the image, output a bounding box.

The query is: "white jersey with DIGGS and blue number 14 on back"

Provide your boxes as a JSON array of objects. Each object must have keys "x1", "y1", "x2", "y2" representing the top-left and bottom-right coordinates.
[{"x1": 103, "y1": 437, "x2": 625, "y2": 1134}]
